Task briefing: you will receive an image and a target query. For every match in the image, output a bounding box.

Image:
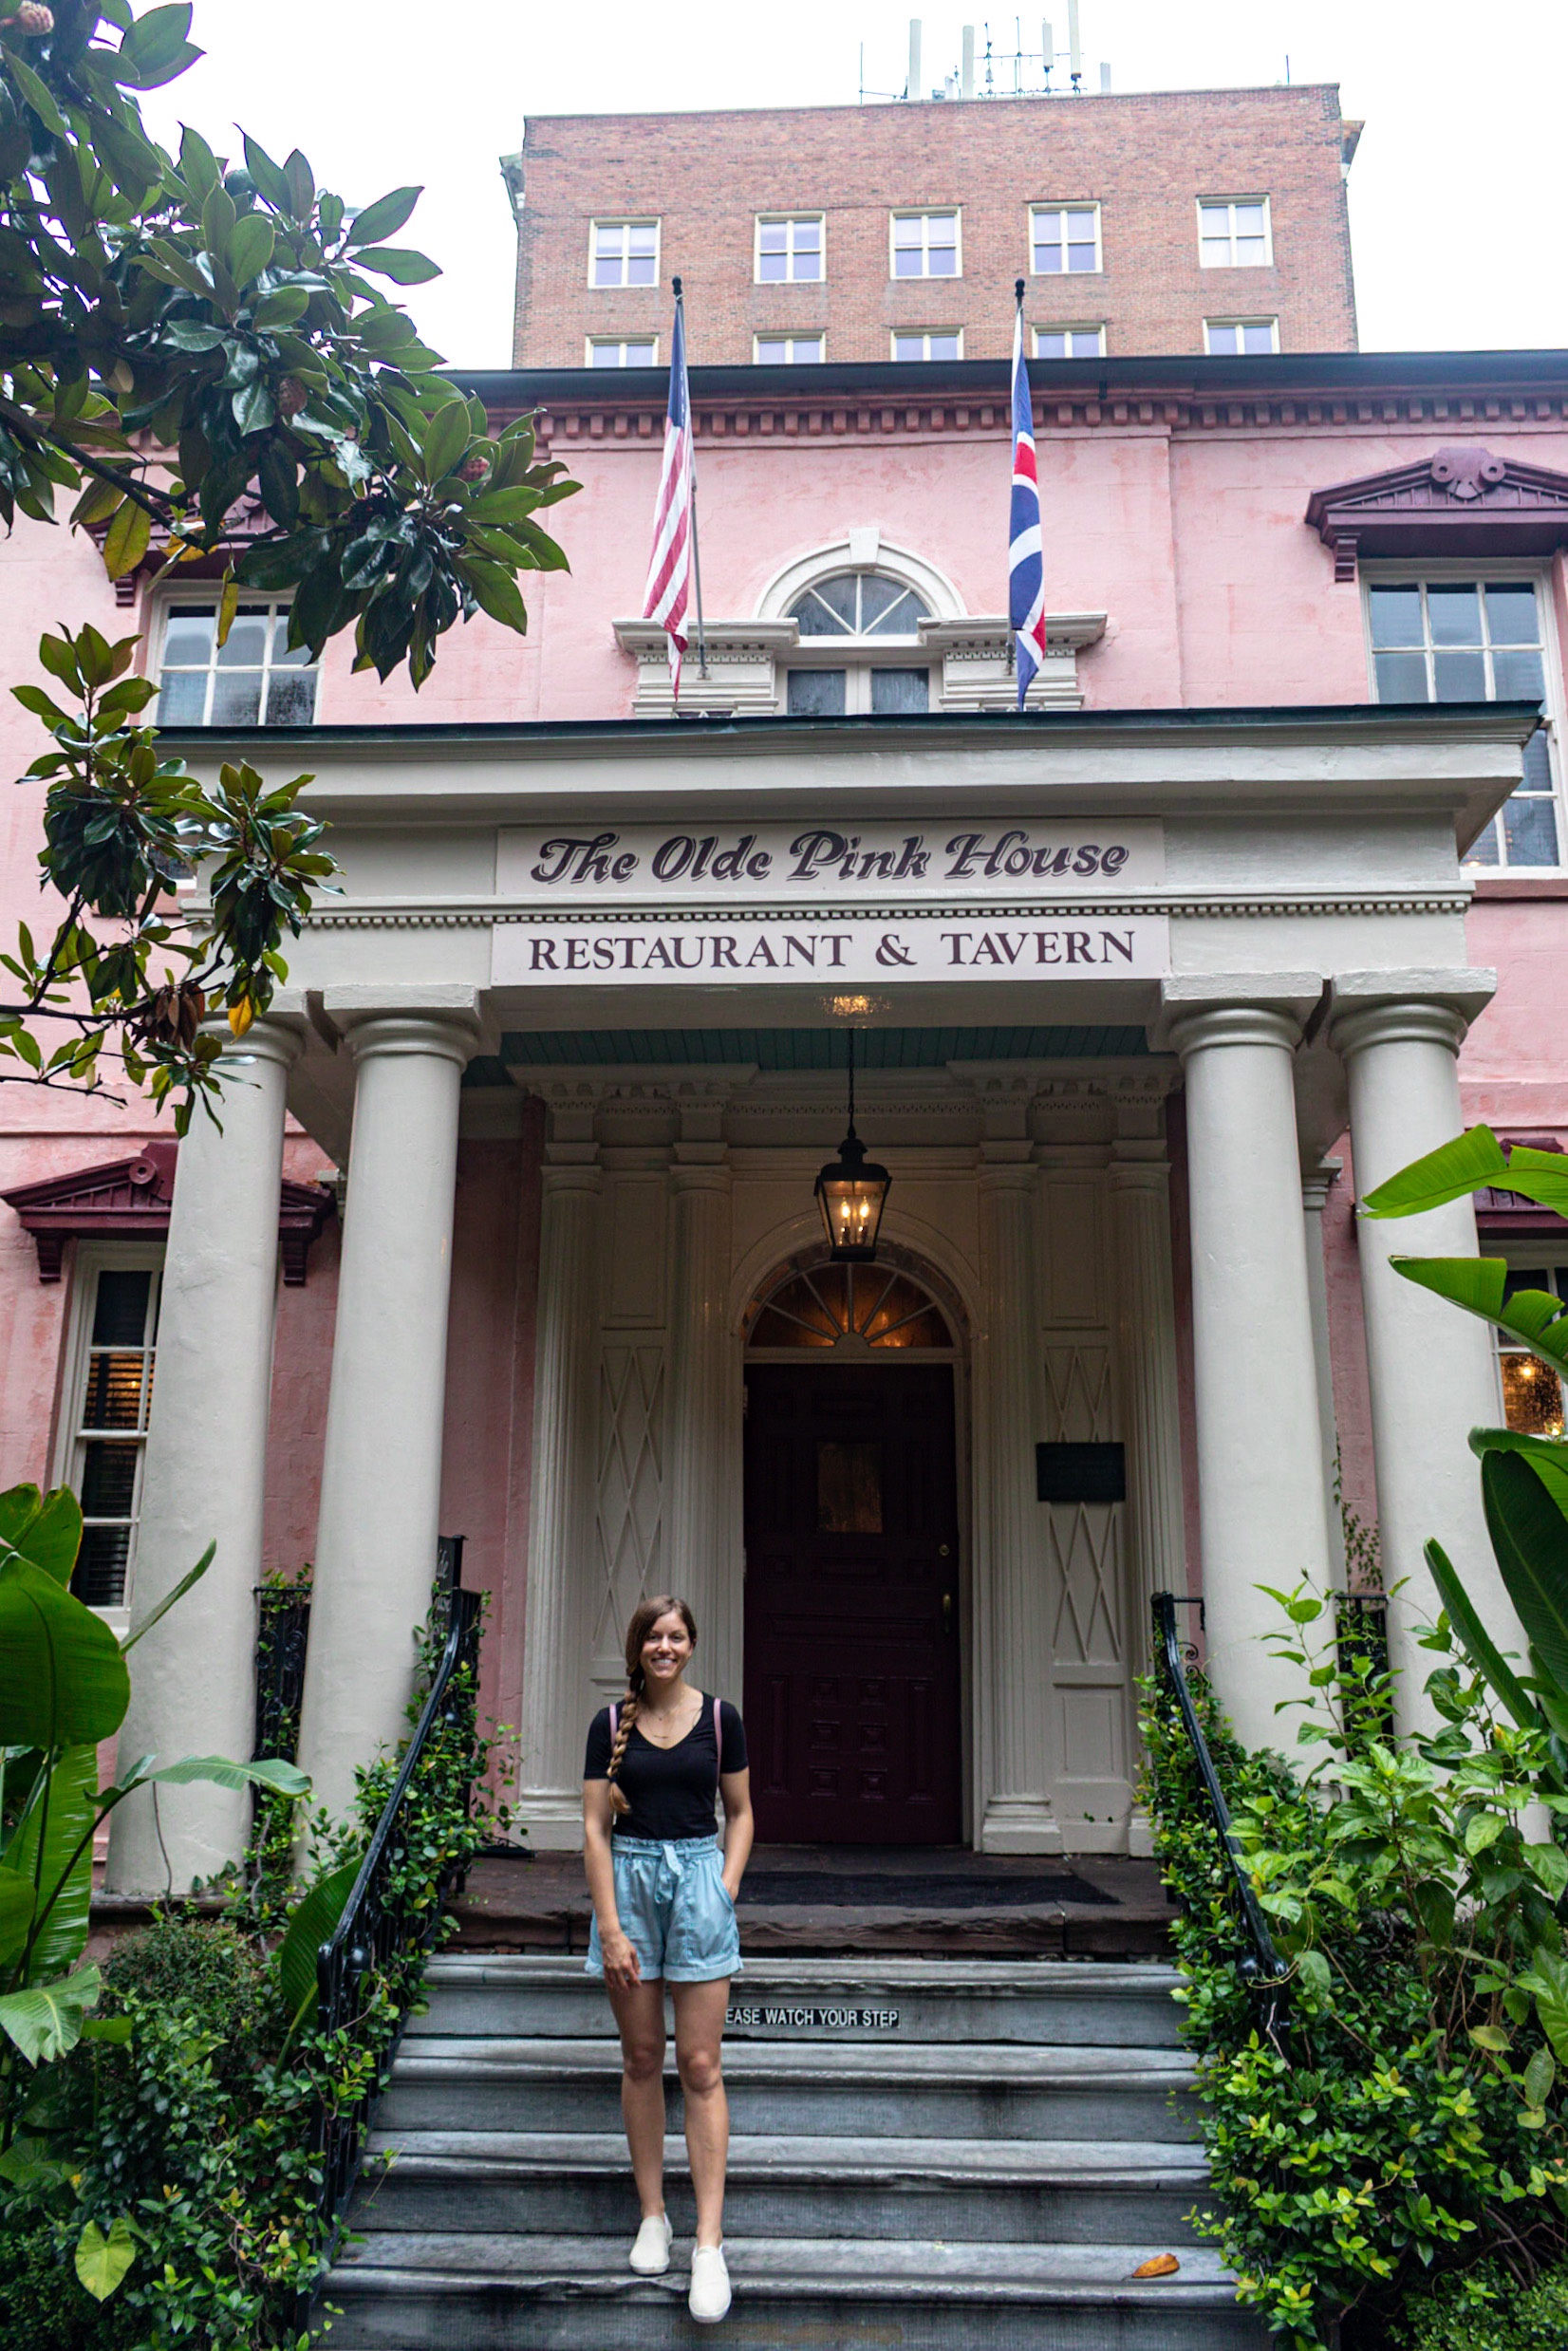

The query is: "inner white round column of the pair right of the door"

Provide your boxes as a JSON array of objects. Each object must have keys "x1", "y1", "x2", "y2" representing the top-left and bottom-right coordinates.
[{"x1": 1162, "y1": 973, "x2": 1328, "y2": 1754}]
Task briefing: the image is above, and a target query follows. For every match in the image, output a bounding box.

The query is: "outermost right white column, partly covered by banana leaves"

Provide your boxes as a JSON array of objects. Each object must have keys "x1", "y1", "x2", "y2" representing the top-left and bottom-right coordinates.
[{"x1": 1328, "y1": 971, "x2": 1523, "y2": 1724}]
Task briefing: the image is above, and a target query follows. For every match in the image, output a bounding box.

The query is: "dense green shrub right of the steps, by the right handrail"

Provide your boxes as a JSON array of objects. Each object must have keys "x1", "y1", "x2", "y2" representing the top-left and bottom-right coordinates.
[{"x1": 1145, "y1": 1617, "x2": 1568, "y2": 2351}]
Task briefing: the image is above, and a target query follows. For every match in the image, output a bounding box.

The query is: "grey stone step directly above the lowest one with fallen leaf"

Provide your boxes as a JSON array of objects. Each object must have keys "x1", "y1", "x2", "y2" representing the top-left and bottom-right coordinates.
[{"x1": 353, "y1": 2128, "x2": 1208, "y2": 2248}]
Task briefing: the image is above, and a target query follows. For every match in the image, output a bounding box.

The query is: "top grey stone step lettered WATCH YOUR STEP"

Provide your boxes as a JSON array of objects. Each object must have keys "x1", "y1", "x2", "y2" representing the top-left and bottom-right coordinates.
[{"x1": 423, "y1": 1953, "x2": 1183, "y2": 2047}]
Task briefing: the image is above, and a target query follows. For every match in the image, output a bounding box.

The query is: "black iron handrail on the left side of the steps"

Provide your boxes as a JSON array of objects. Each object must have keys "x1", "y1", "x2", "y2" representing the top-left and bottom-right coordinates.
[{"x1": 305, "y1": 1535, "x2": 484, "y2": 2257}]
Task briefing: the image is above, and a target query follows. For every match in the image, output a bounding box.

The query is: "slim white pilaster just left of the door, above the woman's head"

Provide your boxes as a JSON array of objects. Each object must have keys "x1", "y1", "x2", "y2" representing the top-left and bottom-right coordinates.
[{"x1": 663, "y1": 1161, "x2": 740, "y2": 1705}]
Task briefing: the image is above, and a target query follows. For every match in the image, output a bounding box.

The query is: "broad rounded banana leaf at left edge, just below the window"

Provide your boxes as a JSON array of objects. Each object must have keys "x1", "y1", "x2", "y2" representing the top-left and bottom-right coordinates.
[{"x1": 0, "y1": 1552, "x2": 132, "y2": 1746}]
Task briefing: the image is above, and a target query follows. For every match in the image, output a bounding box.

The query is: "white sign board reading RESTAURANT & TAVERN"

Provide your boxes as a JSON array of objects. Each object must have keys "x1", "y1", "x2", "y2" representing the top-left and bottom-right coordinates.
[{"x1": 492, "y1": 912, "x2": 1170, "y2": 987}]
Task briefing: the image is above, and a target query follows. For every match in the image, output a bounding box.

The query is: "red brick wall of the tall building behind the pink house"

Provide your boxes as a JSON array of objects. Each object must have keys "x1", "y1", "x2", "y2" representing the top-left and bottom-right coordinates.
[{"x1": 514, "y1": 87, "x2": 1356, "y2": 366}]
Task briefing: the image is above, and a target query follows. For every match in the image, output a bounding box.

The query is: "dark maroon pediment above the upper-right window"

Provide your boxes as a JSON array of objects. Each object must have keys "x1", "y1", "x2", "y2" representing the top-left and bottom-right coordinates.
[{"x1": 1305, "y1": 444, "x2": 1568, "y2": 581}]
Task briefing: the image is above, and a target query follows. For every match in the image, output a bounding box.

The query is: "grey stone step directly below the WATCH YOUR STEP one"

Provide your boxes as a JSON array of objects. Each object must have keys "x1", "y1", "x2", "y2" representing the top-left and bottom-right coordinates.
[{"x1": 376, "y1": 2031, "x2": 1192, "y2": 2139}]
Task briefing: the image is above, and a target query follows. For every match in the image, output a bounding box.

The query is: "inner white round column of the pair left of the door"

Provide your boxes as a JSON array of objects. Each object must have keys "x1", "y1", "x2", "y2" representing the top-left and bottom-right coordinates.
[{"x1": 299, "y1": 997, "x2": 477, "y2": 1815}]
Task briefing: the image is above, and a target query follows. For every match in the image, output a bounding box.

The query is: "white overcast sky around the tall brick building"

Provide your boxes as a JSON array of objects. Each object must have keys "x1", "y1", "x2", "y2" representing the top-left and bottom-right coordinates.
[{"x1": 146, "y1": 0, "x2": 1568, "y2": 366}]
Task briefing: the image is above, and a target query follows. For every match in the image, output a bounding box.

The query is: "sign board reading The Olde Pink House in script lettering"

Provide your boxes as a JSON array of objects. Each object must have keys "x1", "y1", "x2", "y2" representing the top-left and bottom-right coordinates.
[{"x1": 496, "y1": 816, "x2": 1166, "y2": 910}]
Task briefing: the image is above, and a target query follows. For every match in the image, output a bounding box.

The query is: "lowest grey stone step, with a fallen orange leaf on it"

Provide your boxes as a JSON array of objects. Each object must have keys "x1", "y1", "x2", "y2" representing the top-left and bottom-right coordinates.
[{"x1": 325, "y1": 2229, "x2": 1267, "y2": 2351}]
